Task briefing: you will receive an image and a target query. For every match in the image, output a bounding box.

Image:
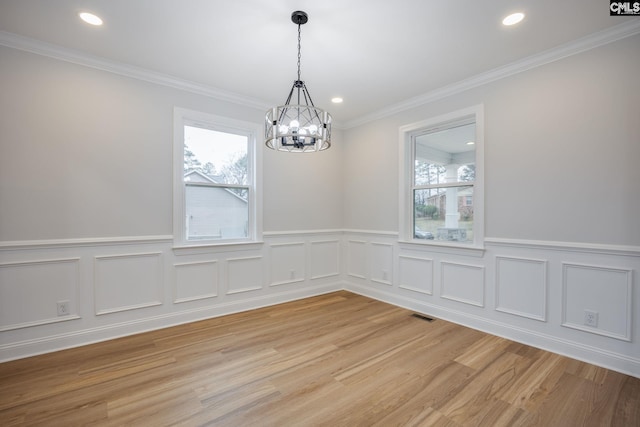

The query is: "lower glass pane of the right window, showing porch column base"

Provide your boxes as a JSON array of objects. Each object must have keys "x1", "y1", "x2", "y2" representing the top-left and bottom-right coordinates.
[{"x1": 413, "y1": 185, "x2": 473, "y2": 243}]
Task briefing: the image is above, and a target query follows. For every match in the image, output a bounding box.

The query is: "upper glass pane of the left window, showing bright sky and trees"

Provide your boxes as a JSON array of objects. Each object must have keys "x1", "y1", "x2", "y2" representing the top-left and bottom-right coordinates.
[{"x1": 184, "y1": 126, "x2": 249, "y2": 184}]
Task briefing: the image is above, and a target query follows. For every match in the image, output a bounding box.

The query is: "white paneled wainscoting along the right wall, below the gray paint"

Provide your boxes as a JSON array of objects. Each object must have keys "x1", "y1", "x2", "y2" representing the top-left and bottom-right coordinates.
[{"x1": 344, "y1": 234, "x2": 640, "y2": 377}]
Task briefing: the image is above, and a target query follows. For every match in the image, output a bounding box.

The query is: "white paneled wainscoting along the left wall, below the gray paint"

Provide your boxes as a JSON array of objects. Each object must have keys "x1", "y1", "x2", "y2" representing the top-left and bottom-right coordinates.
[{"x1": 0, "y1": 230, "x2": 344, "y2": 362}]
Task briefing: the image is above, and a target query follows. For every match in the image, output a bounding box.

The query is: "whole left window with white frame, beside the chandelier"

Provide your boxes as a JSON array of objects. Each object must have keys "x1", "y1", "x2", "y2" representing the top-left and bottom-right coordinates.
[{"x1": 174, "y1": 108, "x2": 261, "y2": 246}]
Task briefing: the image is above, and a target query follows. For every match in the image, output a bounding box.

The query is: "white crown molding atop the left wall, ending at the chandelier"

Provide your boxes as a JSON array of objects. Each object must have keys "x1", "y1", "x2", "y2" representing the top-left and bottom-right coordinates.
[{"x1": 0, "y1": 31, "x2": 271, "y2": 110}]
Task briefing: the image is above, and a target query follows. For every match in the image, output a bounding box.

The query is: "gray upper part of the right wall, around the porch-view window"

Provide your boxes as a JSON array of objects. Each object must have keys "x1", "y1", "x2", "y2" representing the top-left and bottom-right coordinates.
[{"x1": 344, "y1": 36, "x2": 640, "y2": 245}]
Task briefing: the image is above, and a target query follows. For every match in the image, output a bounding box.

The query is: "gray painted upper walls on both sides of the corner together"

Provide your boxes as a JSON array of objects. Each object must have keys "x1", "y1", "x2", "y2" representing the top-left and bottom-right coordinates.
[{"x1": 0, "y1": 36, "x2": 640, "y2": 245}]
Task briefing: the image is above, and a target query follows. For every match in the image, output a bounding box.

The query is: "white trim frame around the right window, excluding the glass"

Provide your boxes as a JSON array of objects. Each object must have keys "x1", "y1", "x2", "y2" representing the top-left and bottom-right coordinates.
[{"x1": 399, "y1": 104, "x2": 484, "y2": 250}]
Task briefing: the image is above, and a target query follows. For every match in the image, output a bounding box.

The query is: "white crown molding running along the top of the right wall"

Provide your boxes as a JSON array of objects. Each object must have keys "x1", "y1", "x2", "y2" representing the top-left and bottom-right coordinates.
[{"x1": 342, "y1": 20, "x2": 640, "y2": 129}]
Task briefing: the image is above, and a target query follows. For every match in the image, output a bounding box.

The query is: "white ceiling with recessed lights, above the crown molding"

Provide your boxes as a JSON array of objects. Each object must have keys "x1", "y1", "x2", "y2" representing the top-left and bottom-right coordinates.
[{"x1": 0, "y1": 0, "x2": 637, "y2": 123}]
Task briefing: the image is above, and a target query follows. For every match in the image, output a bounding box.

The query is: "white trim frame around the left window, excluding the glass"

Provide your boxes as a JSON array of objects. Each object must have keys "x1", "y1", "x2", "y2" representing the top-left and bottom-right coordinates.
[{"x1": 173, "y1": 107, "x2": 264, "y2": 249}]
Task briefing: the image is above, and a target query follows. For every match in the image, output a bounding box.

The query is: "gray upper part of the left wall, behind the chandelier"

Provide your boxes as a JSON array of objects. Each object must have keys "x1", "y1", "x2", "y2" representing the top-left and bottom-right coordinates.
[{"x1": 0, "y1": 47, "x2": 343, "y2": 241}]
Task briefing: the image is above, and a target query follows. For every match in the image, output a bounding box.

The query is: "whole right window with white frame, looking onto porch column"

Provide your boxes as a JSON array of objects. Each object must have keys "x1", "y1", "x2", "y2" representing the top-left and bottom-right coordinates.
[{"x1": 400, "y1": 106, "x2": 484, "y2": 246}]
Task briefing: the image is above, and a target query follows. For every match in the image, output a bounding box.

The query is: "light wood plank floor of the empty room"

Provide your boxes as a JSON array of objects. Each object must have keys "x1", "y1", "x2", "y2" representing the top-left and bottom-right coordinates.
[{"x1": 0, "y1": 292, "x2": 640, "y2": 427}]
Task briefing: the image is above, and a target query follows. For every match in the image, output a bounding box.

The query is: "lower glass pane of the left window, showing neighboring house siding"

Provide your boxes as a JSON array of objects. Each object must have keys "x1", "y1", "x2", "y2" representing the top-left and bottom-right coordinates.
[{"x1": 185, "y1": 184, "x2": 249, "y2": 240}]
